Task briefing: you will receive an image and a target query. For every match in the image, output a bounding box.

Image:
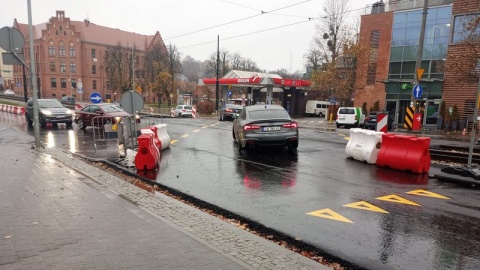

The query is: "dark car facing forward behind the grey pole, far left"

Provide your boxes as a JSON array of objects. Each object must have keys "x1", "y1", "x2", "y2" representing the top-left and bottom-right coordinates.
[{"x1": 25, "y1": 99, "x2": 73, "y2": 127}]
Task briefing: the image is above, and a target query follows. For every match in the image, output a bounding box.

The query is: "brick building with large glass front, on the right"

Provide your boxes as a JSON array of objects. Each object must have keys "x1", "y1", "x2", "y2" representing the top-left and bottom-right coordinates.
[{"x1": 354, "y1": 0, "x2": 480, "y2": 128}]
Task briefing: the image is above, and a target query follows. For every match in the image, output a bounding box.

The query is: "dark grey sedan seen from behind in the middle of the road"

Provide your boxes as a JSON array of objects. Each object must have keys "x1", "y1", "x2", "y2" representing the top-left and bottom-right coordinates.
[{"x1": 232, "y1": 105, "x2": 299, "y2": 150}]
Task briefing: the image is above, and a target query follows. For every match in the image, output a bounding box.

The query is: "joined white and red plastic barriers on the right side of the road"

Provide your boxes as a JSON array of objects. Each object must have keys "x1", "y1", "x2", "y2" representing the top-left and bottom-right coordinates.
[{"x1": 345, "y1": 128, "x2": 431, "y2": 173}]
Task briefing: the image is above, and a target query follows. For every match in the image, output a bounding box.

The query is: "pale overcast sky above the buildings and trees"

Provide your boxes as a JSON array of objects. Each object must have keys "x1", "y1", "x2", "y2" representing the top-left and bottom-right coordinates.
[{"x1": 0, "y1": 0, "x2": 377, "y2": 72}]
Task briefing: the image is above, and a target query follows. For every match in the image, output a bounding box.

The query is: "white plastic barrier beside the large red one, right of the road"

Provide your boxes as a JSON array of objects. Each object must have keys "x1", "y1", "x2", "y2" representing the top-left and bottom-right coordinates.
[{"x1": 345, "y1": 128, "x2": 383, "y2": 164}]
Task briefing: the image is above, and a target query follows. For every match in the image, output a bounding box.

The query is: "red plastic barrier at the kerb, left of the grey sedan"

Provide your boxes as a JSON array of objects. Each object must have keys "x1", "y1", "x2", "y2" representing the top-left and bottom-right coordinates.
[{"x1": 135, "y1": 133, "x2": 160, "y2": 171}]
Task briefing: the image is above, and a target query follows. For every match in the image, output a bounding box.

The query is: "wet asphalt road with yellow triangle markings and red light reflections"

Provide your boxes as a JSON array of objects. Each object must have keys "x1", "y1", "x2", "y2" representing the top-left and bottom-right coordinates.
[{"x1": 0, "y1": 112, "x2": 480, "y2": 269}]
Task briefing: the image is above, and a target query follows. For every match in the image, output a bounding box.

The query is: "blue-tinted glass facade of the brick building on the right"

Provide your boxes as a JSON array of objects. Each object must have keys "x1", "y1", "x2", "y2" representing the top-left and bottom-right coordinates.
[{"x1": 385, "y1": 5, "x2": 452, "y2": 125}]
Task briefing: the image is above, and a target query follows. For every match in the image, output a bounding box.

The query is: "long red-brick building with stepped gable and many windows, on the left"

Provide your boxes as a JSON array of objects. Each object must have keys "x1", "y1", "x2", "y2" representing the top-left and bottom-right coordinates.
[{"x1": 13, "y1": 11, "x2": 165, "y2": 102}]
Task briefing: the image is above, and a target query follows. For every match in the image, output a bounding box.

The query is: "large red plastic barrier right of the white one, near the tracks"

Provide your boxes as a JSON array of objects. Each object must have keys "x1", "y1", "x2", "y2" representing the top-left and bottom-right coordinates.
[{"x1": 377, "y1": 133, "x2": 430, "y2": 173}]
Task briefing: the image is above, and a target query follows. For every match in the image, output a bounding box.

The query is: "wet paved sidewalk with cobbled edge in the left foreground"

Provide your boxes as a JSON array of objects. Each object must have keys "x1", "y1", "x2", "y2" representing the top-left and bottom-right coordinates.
[{"x1": 0, "y1": 125, "x2": 328, "y2": 270}]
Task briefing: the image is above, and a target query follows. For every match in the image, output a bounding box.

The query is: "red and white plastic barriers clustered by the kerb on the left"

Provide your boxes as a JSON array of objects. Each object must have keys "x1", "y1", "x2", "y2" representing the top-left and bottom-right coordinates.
[{"x1": 135, "y1": 124, "x2": 171, "y2": 171}]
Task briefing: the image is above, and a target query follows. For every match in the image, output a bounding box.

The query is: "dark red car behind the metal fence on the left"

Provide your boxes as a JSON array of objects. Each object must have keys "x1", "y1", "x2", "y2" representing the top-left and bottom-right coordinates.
[{"x1": 74, "y1": 103, "x2": 131, "y2": 129}]
